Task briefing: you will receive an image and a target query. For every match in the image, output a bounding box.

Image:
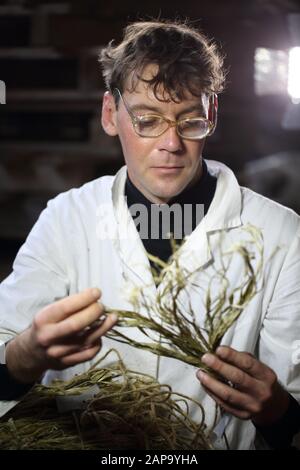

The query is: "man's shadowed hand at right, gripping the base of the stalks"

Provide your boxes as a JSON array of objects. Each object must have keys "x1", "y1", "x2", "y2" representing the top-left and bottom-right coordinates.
[{"x1": 197, "y1": 346, "x2": 289, "y2": 426}]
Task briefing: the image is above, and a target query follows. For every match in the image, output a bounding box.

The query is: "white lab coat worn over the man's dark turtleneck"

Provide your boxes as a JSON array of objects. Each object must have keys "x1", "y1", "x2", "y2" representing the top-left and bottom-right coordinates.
[{"x1": 0, "y1": 160, "x2": 300, "y2": 449}]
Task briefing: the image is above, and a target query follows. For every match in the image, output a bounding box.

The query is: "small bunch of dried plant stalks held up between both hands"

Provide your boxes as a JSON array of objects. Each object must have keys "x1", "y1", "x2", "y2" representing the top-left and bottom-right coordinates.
[{"x1": 106, "y1": 224, "x2": 263, "y2": 370}]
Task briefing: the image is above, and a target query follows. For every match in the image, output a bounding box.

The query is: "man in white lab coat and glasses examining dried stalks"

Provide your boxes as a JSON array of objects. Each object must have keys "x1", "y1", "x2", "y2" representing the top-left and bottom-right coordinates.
[{"x1": 0, "y1": 22, "x2": 300, "y2": 449}]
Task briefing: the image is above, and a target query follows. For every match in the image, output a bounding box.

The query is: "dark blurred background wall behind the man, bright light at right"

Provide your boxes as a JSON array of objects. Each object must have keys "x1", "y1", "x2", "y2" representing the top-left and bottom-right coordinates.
[{"x1": 0, "y1": 0, "x2": 300, "y2": 279}]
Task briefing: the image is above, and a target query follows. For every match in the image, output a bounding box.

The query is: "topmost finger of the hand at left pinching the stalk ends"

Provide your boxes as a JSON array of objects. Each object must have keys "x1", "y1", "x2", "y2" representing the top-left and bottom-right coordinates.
[{"x1": 35, "y1": 287, "x2": 101, "y2": 325}]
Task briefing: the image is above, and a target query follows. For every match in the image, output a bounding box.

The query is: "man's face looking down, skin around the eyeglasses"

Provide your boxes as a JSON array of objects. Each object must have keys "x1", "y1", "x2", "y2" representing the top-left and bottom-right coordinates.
[{"x1": 102, "y1": 70, "x2": 208, "y2": 203}]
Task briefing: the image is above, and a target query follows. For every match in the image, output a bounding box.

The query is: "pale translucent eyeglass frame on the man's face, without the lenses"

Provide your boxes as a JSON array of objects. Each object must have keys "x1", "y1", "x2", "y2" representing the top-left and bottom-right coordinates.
[{"x1": 112, "y1": 88, "x2": 217, "y2": 140}]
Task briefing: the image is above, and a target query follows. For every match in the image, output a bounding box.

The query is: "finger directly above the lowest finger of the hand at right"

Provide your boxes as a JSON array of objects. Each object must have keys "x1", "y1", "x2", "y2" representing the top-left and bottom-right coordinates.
[{"x1": 202, "y1": 354, "x2": 260, "y2": 391}]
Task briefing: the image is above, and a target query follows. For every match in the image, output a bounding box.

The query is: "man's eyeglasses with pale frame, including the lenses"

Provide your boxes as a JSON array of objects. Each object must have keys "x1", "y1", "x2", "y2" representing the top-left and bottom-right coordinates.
[{"x1": 115, "y1": 88, "x2": 215, "y2": 140}]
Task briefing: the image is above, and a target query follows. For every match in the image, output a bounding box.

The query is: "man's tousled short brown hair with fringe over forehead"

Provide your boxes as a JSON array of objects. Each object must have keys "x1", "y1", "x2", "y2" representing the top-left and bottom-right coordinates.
[{"x1": 99, "y1": 21, "x2": 225, "y2": 101}]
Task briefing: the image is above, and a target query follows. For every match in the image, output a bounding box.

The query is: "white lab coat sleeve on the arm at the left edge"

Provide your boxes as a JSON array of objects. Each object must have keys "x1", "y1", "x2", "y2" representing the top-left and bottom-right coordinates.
[{"x1": 0, "y1": 199, "x2": 69, "y2": 416}]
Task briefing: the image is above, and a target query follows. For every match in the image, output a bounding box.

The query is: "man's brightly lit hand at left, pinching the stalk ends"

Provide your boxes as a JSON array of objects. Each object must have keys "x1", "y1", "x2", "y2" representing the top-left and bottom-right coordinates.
[{"x1": 6, "y1": 288, "x2": 117, "y2": 383}]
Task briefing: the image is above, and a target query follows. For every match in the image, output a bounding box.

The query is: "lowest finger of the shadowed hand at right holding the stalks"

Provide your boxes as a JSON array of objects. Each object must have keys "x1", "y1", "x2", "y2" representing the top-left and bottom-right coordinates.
[{"x1": 197, "y1": 371, "x2": 252, "y2": 411}]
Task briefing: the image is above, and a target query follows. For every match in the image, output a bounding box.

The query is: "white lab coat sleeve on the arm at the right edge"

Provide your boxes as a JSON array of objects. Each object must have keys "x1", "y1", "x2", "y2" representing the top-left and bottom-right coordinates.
[{"x1": 259, "y1": 228, "x2": 300, "y2": 402}]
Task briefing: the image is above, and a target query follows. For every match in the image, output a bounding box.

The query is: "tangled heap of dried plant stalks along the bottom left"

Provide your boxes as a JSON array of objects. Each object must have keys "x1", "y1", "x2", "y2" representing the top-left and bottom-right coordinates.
[{"x1": 0, "y1": 350, "x2": 211, "y2": 450}]
